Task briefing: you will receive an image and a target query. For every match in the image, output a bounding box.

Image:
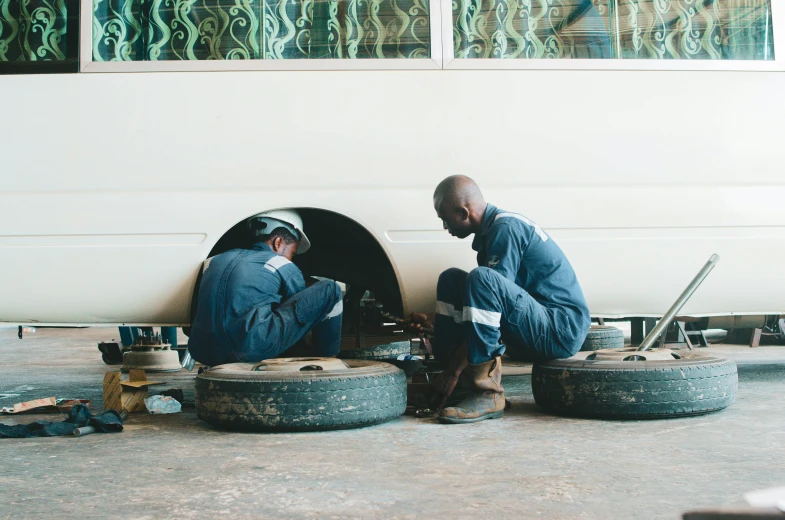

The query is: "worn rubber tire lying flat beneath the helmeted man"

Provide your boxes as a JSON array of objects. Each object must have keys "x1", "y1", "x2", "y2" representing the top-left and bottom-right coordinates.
[{"x1": 196, "y1": 360, "x2": 406, "y2": 431}]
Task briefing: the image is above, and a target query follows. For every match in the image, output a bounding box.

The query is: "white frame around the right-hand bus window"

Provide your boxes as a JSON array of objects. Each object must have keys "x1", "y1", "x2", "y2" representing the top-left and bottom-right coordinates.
[{"x1": 442, "y1": 0, "x2": 785, "y2": 72}]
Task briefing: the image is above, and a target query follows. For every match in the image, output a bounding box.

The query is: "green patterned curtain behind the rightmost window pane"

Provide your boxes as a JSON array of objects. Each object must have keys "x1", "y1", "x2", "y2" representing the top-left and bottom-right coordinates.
[{"x1": 616, "y1": 0, "x2": 774, "y2": 60}]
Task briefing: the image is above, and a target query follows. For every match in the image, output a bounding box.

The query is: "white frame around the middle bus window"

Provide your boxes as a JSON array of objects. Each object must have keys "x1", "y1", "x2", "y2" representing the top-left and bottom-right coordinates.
[{"x1": 79, "y1": 0, "x2": 449, "y2": 73}]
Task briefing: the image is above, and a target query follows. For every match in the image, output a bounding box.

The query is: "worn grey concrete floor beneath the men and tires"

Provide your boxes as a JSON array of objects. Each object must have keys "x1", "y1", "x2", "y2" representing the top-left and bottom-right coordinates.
[{"x1": 0, "y1": 329, "x2": 785, "y2": 519}]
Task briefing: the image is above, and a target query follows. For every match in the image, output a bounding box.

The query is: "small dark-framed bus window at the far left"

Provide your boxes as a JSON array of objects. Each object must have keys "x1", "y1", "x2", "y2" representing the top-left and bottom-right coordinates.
[{"x1": 0, "y1": 0, "x2": 79, "y2": 74}]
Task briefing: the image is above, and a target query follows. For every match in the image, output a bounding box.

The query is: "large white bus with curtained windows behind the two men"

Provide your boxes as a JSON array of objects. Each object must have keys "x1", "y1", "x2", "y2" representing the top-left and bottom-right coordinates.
[{"x1": 0, "y1": 0, "x2": 785, "y2": 332}]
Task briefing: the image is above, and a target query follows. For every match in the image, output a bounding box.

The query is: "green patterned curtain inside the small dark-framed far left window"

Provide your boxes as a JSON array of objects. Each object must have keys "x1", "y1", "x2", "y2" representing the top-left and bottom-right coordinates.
[{"x1": 0, "y1": 0, "x2": 68, "y2": 62}]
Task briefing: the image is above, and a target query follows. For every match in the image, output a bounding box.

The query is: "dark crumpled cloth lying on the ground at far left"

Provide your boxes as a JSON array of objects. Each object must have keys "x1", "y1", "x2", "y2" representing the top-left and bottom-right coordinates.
[{"x1": 0, "y1": 404, "x2": 123, "y2": 439}]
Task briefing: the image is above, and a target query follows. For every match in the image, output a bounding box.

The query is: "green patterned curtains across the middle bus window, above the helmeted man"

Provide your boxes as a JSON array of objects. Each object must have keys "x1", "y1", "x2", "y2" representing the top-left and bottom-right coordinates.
[{"x1": 93, "y1": 0, "x2": 430, "y2": 61}]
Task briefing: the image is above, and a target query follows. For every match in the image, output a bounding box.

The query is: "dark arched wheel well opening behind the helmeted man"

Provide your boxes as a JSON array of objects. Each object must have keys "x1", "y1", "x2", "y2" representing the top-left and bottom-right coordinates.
[{"x1": 210, "y1": 208, "x2": 403, "y2": 316}]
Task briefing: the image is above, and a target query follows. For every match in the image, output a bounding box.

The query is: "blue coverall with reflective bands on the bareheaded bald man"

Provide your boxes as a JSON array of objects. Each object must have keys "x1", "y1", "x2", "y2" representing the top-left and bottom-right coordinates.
[{"x1": 433, "y1": 204, "x2": 591, "y2": 364}]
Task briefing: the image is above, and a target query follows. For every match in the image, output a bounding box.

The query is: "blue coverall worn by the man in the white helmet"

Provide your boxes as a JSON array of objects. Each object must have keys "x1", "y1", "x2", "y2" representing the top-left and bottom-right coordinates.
[{"x1": 188, "y1": 242, "x2": 343, "y2": 366}]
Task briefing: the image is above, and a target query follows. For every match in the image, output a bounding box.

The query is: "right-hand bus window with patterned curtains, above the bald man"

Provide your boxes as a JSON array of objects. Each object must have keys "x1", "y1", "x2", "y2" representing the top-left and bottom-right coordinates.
[{"x1": 452, "y1": 0, "x2": 774, "y2": 60}]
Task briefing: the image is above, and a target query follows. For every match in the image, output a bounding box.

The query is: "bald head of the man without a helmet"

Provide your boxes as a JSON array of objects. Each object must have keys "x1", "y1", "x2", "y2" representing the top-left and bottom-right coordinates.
[{"x1": 433, "y1": 175, "x2": 487, "y2": 238}]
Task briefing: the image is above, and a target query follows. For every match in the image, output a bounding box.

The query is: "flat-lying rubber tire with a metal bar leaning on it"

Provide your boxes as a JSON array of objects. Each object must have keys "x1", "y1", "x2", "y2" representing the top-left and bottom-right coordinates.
[{"x1": 532, "y1": 351, "x2": 738, "y2": 419}]
